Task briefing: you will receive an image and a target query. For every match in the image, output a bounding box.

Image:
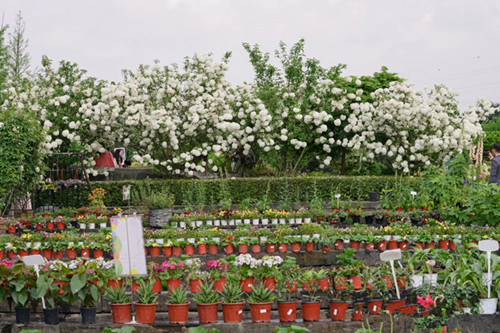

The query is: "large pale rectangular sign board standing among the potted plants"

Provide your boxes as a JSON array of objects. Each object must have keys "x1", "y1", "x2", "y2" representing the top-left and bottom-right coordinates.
[{"x1": 110, "y1": 216, "x2": 148, "y2": 276}]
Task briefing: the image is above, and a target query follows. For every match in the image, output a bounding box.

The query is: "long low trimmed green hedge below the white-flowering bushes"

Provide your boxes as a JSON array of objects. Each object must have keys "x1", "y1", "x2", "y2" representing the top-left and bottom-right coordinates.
[{"x1": 35, "y1": 176, "x2": 420, "y2": 206}]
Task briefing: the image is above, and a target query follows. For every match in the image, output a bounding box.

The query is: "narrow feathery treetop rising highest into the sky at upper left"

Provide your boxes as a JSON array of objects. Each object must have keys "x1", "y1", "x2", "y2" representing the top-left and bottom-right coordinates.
[{"x1": 8, "y1": 11, "x2": 30, "y2": 80}]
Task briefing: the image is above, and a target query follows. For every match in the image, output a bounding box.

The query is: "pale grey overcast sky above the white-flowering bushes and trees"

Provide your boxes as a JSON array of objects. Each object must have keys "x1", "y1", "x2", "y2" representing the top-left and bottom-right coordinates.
[{"x1": 0, "y1": 0, "x2": 500, "y2": 107}]
